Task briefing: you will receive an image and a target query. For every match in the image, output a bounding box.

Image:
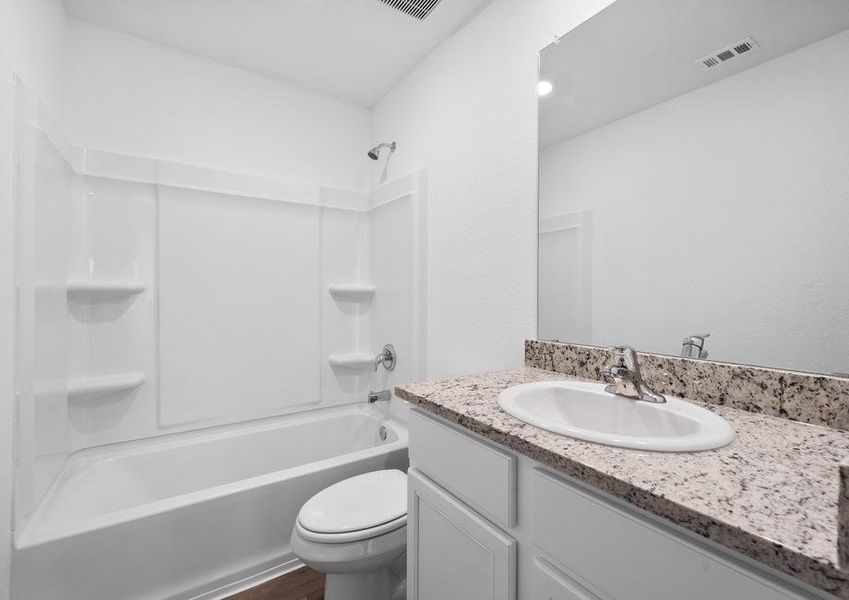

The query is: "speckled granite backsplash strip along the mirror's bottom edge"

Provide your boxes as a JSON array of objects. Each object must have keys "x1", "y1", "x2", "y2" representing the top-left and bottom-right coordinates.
[{"x1": 525, "y1": 340, "x2": 849, "y2": 429}]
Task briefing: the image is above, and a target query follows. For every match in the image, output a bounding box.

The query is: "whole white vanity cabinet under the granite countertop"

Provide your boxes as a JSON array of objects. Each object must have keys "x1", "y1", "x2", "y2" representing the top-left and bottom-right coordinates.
[{"x1": 408, "y1": 409, "x2": 830, "y2": 600}]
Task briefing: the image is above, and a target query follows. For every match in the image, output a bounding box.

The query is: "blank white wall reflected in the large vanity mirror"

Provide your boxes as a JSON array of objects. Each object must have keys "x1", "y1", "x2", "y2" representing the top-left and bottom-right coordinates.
[{"x1": 540, "y1": 31, "x2": 849, "y2": 373}]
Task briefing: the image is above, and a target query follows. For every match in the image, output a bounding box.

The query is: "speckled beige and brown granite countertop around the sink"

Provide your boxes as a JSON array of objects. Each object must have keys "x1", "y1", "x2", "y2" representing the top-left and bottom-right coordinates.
[{"x1": 396, "y1": 367, "x2": 849, "y2": 598}]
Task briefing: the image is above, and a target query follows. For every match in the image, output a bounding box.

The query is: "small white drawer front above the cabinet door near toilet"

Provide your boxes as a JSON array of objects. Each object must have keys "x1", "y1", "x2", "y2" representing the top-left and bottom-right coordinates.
[{"x1": 410, "y1": 409, "x2": 517, "y2": 527}]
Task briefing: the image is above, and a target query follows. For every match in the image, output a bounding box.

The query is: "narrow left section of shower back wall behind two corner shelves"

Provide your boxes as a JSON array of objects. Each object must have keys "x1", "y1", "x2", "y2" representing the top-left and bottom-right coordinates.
[{"x1": 66, "y1": 176, "x2": 158, "y2": 451}]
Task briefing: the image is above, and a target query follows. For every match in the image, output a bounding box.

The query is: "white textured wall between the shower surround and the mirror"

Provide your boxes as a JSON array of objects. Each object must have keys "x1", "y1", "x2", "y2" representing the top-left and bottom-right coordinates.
[{"x1": 374, "y1": 0, "x2": 610, "y2": 377}]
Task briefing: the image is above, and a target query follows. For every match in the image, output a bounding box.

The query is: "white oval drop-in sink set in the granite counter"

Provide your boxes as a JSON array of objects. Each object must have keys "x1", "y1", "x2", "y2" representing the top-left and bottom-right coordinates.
[{"x1": 498, "y1": 381, "x2": 734, "y2": 452}]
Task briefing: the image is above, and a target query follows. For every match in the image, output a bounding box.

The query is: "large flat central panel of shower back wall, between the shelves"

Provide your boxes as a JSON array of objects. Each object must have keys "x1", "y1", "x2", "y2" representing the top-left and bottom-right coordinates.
[{"x1": 159, "y1": 187, "x2": 322, "y2": 426}]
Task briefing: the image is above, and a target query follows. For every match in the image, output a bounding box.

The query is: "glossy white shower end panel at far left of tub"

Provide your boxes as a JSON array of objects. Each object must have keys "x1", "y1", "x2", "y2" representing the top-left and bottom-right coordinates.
[{"x1": 15, "y1": 123, "x2": 79, "y2": 524}]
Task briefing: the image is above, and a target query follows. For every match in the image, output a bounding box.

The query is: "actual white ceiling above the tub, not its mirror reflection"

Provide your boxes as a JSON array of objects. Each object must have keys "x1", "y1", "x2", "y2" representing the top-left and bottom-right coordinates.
[{"x1": 64, "y1": 0, "x2": 491, "y2": 107}]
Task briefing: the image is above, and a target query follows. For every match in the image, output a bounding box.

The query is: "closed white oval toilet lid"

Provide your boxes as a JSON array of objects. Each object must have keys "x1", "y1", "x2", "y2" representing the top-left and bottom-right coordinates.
[{"x1": 298, "y1": 470, "x2": 407, "y2": 533}]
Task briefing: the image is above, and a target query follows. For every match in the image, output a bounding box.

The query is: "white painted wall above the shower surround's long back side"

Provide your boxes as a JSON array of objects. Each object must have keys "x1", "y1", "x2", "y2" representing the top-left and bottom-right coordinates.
[{"x1": 65, "y1": 20, "x2": 371, "y2": 188}]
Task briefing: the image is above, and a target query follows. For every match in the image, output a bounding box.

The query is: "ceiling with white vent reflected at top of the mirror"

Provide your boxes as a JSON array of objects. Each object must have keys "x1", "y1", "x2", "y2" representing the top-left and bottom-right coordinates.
[{"x1": 540, "y1": 0, "x2": 849, "y2": 148}]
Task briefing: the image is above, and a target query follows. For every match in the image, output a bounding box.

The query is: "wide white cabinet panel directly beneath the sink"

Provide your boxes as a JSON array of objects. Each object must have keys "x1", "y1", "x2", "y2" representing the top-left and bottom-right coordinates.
[{"x1": 532, "y1": 469, "x2": 802, "y2": 600}]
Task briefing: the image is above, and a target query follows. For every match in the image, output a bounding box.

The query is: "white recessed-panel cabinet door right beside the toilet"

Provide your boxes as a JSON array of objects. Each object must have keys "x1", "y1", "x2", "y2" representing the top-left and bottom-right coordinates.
[{"x1": 407, "y1": 469, "x2": 516, "y2": 600}]
